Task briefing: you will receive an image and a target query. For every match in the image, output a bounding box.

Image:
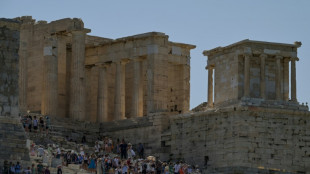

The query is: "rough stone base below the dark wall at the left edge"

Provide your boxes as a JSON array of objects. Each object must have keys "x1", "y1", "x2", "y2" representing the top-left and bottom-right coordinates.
[{"x1": 0, "y1": 116, "x2": 31, "y2": 167}]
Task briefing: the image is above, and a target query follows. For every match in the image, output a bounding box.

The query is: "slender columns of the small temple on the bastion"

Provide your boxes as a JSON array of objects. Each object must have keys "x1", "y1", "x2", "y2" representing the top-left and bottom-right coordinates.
[{"x1": 206, "y1": 54, "x2": 298, "y2": 107}]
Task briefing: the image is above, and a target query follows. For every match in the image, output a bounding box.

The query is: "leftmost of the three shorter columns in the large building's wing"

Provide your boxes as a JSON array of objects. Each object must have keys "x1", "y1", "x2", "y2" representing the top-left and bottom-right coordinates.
[{"x1": 97, "y1": 64, "x2": 109, "y2": 123}]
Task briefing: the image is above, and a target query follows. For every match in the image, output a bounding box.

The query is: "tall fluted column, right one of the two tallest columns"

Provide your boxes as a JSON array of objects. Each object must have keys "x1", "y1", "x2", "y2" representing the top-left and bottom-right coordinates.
[{"x1": 69, "y1": 30, "x2": 86, "y2": 120}]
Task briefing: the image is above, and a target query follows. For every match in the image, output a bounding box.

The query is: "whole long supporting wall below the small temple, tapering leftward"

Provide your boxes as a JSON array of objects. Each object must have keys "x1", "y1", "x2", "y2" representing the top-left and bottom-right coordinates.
[{"x1": 100, "y1": 107, "x2": 310, "y2": 173}]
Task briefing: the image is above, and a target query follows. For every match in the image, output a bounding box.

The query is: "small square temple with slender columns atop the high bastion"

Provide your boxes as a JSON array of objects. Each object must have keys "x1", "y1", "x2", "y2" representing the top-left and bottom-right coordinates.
[{"x1": 203, "y1": 40, "x2": 301, "y2": 107}]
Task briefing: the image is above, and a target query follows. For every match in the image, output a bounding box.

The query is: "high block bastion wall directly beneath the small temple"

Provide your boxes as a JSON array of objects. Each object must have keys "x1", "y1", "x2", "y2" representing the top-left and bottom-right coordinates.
[{"x1": 170, "y1": 107, "x2": 310, "y2": 173}]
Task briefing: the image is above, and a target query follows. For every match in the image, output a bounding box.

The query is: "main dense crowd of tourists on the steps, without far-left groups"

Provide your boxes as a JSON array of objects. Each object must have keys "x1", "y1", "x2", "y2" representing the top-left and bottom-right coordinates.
[{"x1": 43, "y1": 137, "x2": 200, "y2": 174}]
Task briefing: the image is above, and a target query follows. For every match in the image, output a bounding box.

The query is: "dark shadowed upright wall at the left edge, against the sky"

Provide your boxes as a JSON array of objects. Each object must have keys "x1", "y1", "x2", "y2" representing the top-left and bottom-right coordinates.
[{"x1": 0, "y1": 18, "x2": 20, "y2": 116}]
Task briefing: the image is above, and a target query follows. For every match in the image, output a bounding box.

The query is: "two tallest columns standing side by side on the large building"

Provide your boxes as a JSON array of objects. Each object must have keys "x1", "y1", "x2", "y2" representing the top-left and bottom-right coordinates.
[{"x1": 41, "y1": 29, "x2": 88, "y2": 120}]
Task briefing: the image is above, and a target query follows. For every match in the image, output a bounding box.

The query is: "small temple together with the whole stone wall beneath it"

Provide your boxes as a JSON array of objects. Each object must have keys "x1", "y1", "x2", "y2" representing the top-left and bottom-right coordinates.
[{"x1": 100, "y1": 40, "x2": 310, "y2": 173}]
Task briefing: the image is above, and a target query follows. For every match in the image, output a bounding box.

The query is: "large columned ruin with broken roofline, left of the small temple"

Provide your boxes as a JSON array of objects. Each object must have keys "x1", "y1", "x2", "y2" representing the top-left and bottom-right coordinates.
[{"x1": 15, "y1": 17, "x2": 195, "y2": 122}]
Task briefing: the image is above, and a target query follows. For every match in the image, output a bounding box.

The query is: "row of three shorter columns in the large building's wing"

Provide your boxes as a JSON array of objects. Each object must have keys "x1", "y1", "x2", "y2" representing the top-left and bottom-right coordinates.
[{"x1": 96, "y1": 58, "x2": 143, "y2": 122}]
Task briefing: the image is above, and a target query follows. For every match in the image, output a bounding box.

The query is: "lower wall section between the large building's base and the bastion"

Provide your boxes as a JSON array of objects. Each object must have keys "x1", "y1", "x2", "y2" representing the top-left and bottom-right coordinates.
[{"x1": 100, "y1": 113, "x2": 170, "y2": 160}]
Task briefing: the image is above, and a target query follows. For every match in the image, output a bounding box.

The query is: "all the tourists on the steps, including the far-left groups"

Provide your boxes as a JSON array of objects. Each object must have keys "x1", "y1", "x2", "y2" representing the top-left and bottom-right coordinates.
[{"x1": 2, "y1": 115, "x2": 200, "y2": 174}]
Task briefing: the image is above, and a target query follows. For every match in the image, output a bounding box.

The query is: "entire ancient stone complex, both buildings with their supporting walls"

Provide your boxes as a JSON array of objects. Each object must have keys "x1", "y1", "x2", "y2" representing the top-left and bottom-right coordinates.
[{"x1": 0, "y1": 17, "x2": 310, "y2": 174}]
